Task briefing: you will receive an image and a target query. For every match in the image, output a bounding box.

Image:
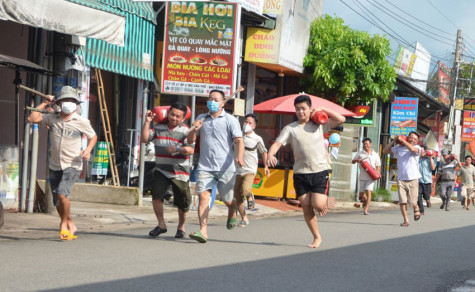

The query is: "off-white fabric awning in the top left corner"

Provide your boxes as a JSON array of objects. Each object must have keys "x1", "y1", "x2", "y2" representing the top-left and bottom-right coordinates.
[{"x1": 0, "y1": 0, "x2": 126, "y2": 46}]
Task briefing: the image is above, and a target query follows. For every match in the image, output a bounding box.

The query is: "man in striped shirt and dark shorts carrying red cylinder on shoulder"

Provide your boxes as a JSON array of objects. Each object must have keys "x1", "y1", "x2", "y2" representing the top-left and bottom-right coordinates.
[{"x1": 142, "y1": 102, "x2": 194, "y2": 238}]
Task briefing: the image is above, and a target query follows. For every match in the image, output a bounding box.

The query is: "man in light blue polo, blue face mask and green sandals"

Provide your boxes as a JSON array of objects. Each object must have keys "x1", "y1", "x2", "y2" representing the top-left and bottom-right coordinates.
[{"x1": 188, "y1": 90, "x2": 244, "y2": 243}]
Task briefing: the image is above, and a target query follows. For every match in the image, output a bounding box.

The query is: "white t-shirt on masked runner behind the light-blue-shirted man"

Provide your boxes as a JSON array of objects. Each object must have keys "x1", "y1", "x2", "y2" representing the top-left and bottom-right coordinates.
[{"x1": 235, "y1": 132, "x2": 267, "y2": 174}]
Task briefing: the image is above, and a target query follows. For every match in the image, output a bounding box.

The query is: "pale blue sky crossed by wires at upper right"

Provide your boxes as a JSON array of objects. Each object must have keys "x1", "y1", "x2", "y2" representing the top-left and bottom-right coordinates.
[{"x1": 323, "y1": 0, "x2": 475, "y2": 69}]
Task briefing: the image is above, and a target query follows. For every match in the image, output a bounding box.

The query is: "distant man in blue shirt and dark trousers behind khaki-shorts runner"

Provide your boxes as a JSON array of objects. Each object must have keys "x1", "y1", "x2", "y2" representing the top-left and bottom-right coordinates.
[{"x1": 417, "y1": 145, "x2": 435, "y2": 215}]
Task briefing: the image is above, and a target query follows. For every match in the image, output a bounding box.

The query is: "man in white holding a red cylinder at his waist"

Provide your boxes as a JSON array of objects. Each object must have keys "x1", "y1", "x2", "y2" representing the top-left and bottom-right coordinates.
[{"x1": 351, "y1": 138, "x2": 381, "y2": 215}]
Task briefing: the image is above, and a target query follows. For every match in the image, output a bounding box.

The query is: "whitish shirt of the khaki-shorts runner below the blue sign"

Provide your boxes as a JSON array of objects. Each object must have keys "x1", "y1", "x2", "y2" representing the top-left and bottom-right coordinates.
[{"x1": 391, "y1": 145, "x2": 422, "y2": 180}]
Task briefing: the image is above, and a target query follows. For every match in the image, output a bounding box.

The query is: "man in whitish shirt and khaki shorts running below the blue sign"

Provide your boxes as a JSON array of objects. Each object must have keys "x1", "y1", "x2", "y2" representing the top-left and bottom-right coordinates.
[{"x1": 383, "y1": 132, "x2": 422, "y2": 227}]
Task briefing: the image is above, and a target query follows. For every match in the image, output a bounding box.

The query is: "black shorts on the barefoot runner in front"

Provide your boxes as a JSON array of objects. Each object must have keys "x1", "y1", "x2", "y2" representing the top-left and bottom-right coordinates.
[{"x1": 294, "y1": 170, "x2": 330, "y2": 197}]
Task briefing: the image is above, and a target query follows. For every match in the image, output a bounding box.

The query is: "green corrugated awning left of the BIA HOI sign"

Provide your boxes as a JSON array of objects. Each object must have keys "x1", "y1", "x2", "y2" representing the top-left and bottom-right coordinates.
[{"x1": 81, "y1": 0, "x2": 156, "y2": 81}]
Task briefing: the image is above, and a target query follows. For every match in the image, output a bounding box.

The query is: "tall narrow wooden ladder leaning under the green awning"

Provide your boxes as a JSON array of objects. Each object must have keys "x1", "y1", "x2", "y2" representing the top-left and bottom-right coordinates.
[{"x1": 95, "y1": 68, "x2": 120, "y2": 186}]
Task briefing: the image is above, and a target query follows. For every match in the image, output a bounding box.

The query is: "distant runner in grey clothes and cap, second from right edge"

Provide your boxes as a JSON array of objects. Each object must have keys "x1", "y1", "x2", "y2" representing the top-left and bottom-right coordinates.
[{"x1": 437, "y1": 149, "x2": 459, "y2": 211}]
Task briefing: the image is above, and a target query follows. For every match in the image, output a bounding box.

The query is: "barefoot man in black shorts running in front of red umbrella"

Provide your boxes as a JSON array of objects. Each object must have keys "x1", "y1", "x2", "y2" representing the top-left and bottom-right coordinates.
[{"x1": 267, "y1": 95, "x2": 345, "y2": 248}]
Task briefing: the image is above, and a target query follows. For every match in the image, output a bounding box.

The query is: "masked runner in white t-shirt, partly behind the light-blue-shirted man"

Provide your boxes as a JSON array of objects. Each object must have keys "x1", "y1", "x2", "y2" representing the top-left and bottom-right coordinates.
[{"x1": 234, "y1": 114, "x2": 270, "y2": 227}]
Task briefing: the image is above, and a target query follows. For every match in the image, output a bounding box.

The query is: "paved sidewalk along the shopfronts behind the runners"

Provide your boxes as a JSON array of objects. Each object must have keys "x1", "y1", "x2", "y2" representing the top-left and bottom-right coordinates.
[{"x1": 0, "y1": 198, "x2": 398, "y2": 242}]
